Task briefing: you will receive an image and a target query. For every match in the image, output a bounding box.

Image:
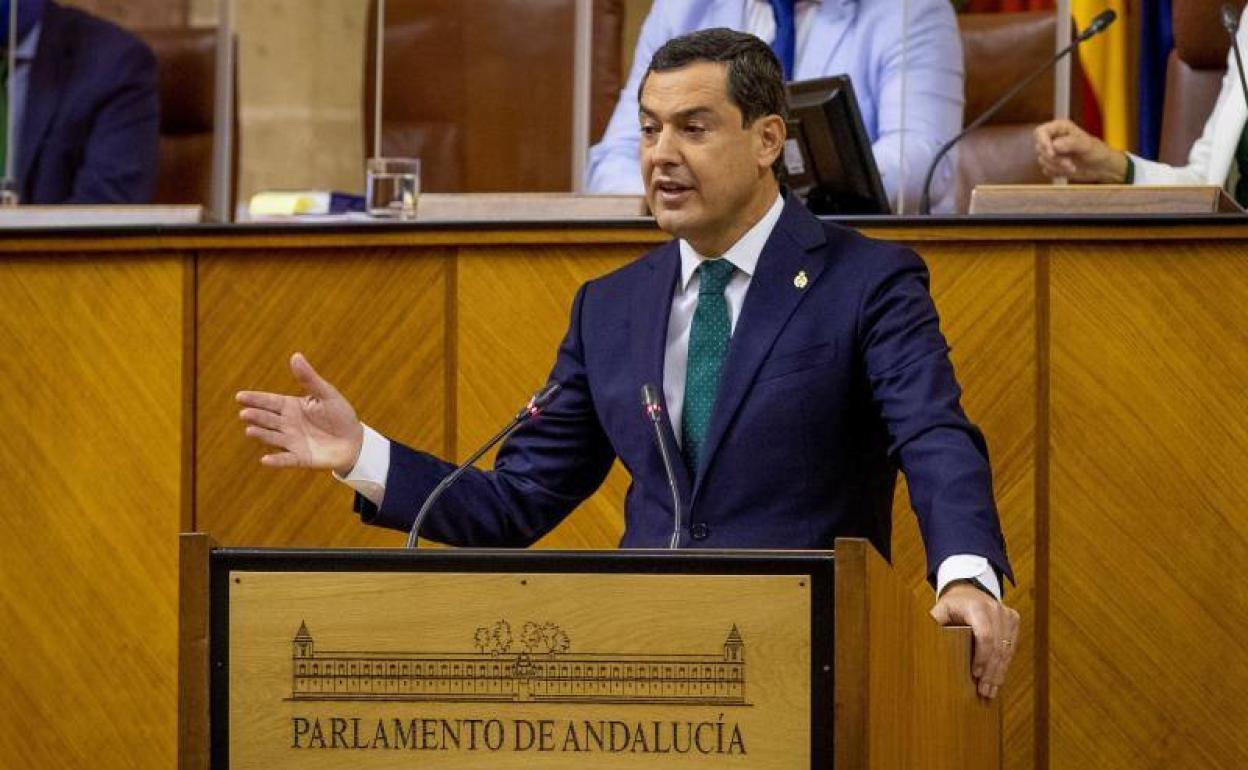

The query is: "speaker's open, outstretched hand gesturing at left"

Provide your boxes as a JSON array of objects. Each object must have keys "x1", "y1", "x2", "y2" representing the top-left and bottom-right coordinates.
[{"x1": 235, "y1": 353, "x2": 364, "y2": 475}]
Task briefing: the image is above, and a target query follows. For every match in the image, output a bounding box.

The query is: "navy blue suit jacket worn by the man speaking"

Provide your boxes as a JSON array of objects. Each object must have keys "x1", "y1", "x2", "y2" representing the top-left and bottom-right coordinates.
[{"x1": 357, "y1": 197, "x2": 1010, "y2": 575}]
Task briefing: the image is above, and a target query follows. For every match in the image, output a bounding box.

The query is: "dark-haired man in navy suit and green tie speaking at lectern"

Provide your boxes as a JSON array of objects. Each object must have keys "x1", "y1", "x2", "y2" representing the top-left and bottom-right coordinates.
[{"x1": 238, "y1": 29, "x2": 1018, "y2": 698}]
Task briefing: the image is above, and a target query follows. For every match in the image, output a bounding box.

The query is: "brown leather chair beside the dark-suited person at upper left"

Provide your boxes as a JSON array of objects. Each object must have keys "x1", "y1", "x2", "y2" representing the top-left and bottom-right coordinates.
[{"x1": 135, "y1": 27, "x2": 238, "y2": 210}]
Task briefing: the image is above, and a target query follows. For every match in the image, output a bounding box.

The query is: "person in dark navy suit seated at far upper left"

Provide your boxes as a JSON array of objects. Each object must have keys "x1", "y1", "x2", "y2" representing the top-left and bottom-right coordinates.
[{"x1": 0, "y1": 0, "x2": 160, "y2": 203}]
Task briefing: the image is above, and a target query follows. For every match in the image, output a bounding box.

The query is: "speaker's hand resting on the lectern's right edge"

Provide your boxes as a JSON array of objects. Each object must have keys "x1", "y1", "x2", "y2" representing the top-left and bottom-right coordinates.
[{"x1": 931, "y1": 583, "x2": 1018, "y2": 698}]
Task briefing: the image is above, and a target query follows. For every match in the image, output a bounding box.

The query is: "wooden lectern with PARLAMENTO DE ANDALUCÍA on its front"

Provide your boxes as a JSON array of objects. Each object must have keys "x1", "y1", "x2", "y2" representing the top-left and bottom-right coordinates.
[{"x1": 178, "y1": 534, "x2": 1001, "y2": 770}]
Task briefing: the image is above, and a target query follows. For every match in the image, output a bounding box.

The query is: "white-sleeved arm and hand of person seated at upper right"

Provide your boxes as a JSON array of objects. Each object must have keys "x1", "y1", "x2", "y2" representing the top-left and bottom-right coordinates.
[{"x1": 1035, "y1": 7, "x2": 1248, "y2": 206}]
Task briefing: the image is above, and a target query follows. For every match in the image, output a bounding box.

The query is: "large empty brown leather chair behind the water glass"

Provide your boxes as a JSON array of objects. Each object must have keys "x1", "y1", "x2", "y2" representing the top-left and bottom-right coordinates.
[{"x1": 361, "y1": 0, "x2": 624, "y2": 192}]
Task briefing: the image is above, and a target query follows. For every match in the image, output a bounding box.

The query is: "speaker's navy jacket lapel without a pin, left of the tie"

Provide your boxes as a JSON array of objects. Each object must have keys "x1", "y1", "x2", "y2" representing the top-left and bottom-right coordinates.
[{"x1": 629, "y1": 240, "x2": 693, "y2": 503}]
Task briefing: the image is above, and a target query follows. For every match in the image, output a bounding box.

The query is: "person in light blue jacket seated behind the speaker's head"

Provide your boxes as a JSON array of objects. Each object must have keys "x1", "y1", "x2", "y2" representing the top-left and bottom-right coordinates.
[{"x1": 587, "y1": 0, "x2": 963, "y2": 212}]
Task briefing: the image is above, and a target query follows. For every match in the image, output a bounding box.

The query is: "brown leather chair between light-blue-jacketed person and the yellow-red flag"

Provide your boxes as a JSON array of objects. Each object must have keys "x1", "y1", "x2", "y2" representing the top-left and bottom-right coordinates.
[{"x1": 956, "y1": 11, "x2": 1080, "y2": 212}]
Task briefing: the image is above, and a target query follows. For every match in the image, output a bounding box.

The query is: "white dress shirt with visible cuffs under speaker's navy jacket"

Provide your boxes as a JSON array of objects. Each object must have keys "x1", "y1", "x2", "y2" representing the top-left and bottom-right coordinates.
[{"x1": 334, "y1": 190, "x2": 1001, "y2": 599}]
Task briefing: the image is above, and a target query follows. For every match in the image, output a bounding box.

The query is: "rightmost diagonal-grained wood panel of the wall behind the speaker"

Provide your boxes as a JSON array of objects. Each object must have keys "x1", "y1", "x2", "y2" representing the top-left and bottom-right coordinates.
[{"x1": 1050, "y1": 242, "x2": 1248, "y2": 770}]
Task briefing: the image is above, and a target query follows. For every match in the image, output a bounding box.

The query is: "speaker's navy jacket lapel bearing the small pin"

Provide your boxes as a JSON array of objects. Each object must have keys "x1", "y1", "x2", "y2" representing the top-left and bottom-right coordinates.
[{"x1": 693, "y1": 195, "x2": 826, "y2": 499}]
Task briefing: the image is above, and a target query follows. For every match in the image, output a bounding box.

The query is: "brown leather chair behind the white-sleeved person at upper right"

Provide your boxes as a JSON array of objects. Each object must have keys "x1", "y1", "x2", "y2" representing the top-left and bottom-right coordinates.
[{"x1": 1158, "y1": 0, "x2": 1243, "y2": 166}]
